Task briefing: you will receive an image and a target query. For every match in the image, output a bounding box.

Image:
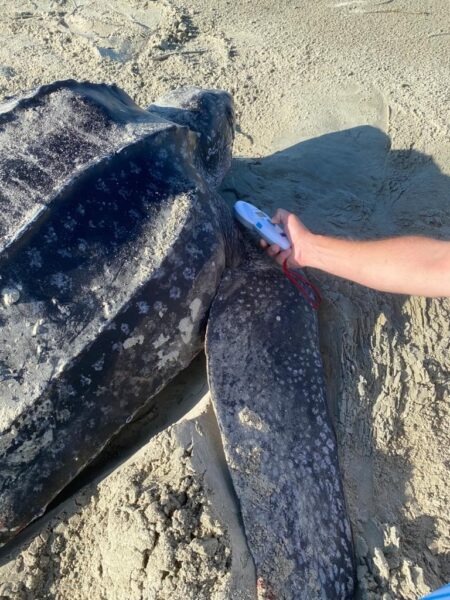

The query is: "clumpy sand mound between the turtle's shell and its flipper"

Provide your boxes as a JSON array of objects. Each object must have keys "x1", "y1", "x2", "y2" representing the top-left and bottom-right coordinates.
[{"x1": 0, "y1": 397, "x2": 255, "y2": 600}]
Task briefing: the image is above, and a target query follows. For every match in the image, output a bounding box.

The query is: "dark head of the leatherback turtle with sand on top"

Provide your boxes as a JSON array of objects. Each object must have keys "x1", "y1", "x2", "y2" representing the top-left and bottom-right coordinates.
[{"x1": 148, "y1": 87, "x2": 234, "y2": 188}]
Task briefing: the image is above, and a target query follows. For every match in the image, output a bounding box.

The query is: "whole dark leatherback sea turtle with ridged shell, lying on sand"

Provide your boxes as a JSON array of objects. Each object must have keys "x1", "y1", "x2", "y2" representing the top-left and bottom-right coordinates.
[{"x1": 0, "y1": 81, "x2": 353, "y2": 600}]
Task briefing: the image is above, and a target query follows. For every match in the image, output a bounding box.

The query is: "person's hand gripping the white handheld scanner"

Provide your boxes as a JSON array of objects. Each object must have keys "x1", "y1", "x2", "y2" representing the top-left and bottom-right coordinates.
[{"x1": 260, "y1": 208, "x2": 313, "y2": 268}]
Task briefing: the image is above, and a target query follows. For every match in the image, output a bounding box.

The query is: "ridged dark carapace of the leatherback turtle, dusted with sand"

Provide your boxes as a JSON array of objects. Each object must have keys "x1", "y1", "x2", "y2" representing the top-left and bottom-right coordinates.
[{"x1": 0, "y1": 82, "x2": 232, "y2": 543}]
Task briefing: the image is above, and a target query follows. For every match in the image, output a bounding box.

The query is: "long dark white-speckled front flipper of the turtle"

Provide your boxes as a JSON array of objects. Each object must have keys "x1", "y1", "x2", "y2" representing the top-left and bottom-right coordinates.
[{"x1": 206, "y1": 255, "x2": 354, "y2": 600}]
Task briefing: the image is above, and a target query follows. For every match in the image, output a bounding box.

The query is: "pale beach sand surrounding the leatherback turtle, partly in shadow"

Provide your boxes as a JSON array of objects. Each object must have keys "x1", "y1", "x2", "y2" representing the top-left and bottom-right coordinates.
[{"x1": 0, "y1": 0, "x2": 450, "y2": 600}]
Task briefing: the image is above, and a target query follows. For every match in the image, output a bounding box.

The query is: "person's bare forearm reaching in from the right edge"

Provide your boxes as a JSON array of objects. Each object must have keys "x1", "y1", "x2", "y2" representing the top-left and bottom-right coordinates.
[{"x1": 302, "y1": 235, "x2": 450, "y2": 297}]
